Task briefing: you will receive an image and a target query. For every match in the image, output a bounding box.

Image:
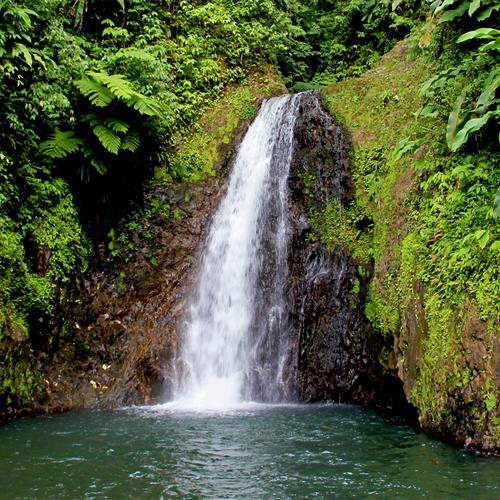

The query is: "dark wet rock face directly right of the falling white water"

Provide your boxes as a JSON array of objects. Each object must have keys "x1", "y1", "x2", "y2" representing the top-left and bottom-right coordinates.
[{"x1": 288, "y1": 93, "x2": 394, "y2": 403}]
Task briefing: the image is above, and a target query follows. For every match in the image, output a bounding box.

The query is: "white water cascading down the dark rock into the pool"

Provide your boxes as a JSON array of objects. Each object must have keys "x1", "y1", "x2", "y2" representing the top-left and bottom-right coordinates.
[{"x1": 170, "y1": 96, "x2": 298, "y2": 408}]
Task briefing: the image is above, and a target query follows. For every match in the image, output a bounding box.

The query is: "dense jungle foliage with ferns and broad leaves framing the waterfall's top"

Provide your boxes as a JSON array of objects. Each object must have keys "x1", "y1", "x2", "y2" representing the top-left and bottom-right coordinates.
[{"x1": 0, "y1": 0, "x2": 500, "y2": 418}]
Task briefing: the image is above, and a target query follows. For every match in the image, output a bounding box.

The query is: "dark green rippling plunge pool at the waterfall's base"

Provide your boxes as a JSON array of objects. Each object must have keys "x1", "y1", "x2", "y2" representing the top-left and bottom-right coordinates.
[{"x1": 0, "y1": 404, "x2": 500, "y2": 499}]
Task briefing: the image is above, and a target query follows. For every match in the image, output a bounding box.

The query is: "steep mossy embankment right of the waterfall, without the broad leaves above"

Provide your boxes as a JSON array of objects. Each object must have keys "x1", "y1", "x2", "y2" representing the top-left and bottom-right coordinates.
[{"x1": 313, "y1": 42, "x2": 500, "y2": 451}]
